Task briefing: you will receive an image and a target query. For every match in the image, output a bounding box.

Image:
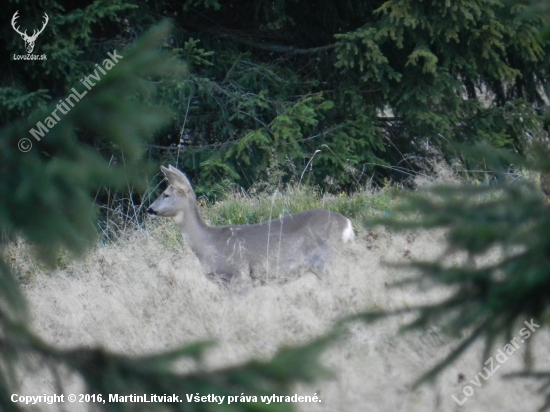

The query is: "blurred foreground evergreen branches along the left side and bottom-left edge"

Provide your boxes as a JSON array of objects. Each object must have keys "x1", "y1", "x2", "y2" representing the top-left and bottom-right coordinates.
[{"x1": 0, "y1": 24, "x2": 334, "y2": 411}]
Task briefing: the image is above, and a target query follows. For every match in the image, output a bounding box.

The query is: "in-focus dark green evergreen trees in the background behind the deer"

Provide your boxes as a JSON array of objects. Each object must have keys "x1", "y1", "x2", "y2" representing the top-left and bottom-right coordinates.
[{"x1": 0, "y1": 0, "x2": 548, "y2": 194}]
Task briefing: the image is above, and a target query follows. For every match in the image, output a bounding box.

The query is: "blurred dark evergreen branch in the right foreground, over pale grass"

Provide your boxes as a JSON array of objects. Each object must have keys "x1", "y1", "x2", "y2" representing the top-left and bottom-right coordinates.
[{"x1": 354, "y1": 146, "x2": 550, "y2": 410}]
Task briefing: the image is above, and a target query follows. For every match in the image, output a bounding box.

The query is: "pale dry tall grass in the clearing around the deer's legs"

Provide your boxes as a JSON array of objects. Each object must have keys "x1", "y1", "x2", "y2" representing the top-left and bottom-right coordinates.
[{"x1": 8, "y1": 183, "x2": 549, "y2": 412}]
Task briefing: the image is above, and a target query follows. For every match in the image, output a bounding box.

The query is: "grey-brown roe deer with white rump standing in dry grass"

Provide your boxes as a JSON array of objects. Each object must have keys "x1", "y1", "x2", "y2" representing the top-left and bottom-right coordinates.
[{"x1": 147, "y1": 166, "x2": 354, "y2": 286}]
